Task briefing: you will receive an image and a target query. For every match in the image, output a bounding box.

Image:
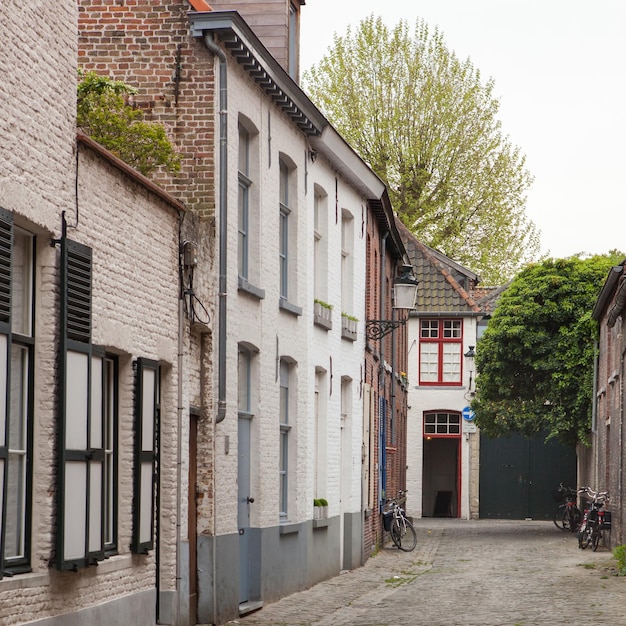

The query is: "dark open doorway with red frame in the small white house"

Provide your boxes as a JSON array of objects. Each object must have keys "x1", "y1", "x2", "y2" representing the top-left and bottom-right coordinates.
[{"x1": 422, "y1": 437, "x2": 461, "y2": 517}]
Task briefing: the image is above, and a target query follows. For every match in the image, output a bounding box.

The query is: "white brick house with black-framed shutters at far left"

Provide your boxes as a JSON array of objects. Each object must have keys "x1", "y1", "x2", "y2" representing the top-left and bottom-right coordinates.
[{"x1": 0, "y1": 0, "x2": 191, "y2": 626}]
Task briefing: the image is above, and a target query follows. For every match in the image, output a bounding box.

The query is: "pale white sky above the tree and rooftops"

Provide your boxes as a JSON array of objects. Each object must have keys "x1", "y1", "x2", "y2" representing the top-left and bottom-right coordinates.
[{"x1": 300, "y1": 0, "x2": 626, "y2": 257}]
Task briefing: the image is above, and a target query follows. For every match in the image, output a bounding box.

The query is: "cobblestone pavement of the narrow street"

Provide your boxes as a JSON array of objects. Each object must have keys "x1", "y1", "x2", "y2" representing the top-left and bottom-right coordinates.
[{"x1": 224, "y1": 519, "x2": 626, "y2": 626}]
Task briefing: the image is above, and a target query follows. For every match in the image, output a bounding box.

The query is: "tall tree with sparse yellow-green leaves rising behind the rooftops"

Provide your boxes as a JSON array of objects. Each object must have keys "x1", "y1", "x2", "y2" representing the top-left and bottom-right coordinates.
[{"x1": 303, "y1": 15, "x2": 539, "y2": 285}]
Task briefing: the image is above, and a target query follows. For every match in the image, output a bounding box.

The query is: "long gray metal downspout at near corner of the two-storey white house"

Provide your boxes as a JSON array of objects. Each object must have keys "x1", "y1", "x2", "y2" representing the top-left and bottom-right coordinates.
[{"x1": 204, "y1": 33, "x2": 228, "y2": 624}]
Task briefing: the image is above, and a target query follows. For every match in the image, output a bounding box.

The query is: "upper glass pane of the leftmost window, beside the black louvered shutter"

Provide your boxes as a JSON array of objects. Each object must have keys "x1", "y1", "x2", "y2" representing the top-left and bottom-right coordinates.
[{"x1": 11, "y1": 228, "x2": 33, "y2": 336}]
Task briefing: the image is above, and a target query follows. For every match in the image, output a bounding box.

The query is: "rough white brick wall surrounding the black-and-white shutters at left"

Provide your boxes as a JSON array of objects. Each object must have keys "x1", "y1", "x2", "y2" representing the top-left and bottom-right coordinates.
[{"x1": 0, "y1": 0, "x2": 184, "y2": 626}]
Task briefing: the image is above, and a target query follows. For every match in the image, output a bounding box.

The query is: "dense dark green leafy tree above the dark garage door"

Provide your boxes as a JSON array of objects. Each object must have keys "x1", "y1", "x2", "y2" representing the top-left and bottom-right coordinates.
[{"x1": 472, "y1": 252, "x2": 624, "y2": 445}]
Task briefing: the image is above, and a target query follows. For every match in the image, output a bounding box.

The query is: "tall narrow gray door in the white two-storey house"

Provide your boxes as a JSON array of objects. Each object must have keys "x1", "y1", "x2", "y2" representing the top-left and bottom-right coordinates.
[{"x1": 237, "y1": 417, "x2": 252, "y2": 604}]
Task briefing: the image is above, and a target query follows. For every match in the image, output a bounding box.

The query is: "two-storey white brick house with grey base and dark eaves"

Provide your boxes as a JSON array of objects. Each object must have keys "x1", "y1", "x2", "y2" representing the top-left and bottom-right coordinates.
[{"x1": 185, "y1": 11, "x2": 392, "y2": 622}]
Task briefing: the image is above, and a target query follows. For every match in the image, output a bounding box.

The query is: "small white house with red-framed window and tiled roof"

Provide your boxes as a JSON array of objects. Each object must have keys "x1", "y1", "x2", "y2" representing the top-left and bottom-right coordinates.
[{"x1": 399, "y1": 225, "x2": 483, "y2": 519}]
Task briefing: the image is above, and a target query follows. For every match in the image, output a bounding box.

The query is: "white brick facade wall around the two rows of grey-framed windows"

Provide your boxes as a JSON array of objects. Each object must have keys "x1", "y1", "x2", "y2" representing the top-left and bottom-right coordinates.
[{"x1": 216, "y1": 64, "x2": 365, "y2": 534}]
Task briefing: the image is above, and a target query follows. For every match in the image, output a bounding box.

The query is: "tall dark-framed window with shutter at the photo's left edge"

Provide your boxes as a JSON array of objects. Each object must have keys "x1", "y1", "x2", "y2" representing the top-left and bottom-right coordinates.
[{"x1": 0, "y1": 210, "x2": 34, "y2": 578}]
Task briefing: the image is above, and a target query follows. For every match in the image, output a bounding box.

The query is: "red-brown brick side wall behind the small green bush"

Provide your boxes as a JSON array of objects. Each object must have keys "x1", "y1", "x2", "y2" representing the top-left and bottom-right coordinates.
[{"x1": 78, "y1": 0, "x2": 215, "y2": 217}]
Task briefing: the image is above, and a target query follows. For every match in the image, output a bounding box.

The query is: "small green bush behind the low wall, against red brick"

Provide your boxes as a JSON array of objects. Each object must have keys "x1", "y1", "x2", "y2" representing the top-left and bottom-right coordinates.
[{"x1": 76, "y1": 72, "x2": 180, "y2": 176}]
